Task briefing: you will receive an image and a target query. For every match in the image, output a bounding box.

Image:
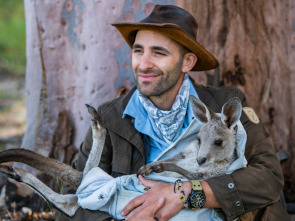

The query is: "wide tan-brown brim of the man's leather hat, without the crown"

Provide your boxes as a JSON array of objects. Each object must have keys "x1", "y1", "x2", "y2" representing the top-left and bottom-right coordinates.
[{"x1": 112, "y1": 22, "x2": 218, "y2": 71}]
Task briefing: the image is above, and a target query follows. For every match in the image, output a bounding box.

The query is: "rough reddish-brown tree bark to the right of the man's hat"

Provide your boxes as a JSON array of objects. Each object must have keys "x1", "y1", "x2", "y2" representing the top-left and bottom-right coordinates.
[{"x1": 184, "y1": 0, "x2": 295, "y2": 187}]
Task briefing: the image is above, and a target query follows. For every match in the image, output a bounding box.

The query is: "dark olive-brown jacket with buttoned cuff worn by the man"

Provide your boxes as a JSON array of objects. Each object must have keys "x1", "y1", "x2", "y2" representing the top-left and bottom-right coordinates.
[{"x1": 58, "y1": 84, "x2": 288, "y2": 221}]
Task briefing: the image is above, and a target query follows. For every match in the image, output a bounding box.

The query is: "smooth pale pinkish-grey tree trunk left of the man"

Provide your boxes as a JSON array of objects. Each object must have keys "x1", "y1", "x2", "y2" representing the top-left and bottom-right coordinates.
[{"x1": 22, "y1": 0, "x2": 124, "y2": 164}]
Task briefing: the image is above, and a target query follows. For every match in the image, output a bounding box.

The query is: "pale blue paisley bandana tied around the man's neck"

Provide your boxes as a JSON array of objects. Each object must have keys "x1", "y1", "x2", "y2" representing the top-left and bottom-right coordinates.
[{"x1": 139, "y1": 74, "x2": 190, "y2": 143}]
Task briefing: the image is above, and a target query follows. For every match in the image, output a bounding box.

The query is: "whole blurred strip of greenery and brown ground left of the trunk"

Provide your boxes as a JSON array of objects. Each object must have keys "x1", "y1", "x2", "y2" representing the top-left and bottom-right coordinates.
[{"x1": 0, "y1": 0, "x2": 26, "y2": 150}]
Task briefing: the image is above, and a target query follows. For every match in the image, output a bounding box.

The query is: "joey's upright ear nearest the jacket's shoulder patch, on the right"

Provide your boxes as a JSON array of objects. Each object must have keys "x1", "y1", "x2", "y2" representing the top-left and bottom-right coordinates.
[{"x1": 221, "y1": 97, "x2": 242, "y2": 129}]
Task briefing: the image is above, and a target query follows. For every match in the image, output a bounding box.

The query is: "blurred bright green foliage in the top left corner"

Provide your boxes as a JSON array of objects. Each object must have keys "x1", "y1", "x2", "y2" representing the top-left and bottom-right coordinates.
[{"x1": 0, "y1": 0, "x2": 26, "y2": 75}]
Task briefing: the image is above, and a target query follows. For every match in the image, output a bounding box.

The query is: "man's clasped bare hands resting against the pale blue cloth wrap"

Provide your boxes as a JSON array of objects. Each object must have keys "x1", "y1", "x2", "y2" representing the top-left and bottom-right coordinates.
[{"x1": 122, "y1": 176, "x2": 191, "y2": 221}]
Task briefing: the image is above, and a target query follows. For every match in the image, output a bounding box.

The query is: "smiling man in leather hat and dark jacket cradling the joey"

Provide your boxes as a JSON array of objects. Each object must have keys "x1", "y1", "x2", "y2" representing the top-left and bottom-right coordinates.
[{"x1": 56, "y1": 5, "x2": 286, "y2": 220}]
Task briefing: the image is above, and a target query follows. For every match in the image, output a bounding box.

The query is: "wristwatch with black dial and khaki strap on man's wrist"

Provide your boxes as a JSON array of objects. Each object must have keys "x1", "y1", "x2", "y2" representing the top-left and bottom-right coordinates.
[{"x1": 187, "y1": 180, "x2": 206, "y2": 209}]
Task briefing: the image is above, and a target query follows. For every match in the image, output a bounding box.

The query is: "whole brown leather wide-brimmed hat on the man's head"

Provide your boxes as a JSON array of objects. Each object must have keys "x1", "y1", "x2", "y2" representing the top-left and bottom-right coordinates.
[{"x1": 112, "y1": 5, "x2": 218, "y2": 71}]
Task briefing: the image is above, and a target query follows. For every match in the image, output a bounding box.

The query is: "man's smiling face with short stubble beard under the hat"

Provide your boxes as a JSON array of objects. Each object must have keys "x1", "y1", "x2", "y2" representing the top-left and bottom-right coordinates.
[{"x1": 132, "y1": 30, "x2": 183, "y2": 96}]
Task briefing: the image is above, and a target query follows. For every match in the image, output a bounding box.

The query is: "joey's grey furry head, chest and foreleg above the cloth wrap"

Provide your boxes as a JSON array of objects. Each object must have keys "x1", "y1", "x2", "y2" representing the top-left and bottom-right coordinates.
[{"x1": 138, "y1": 96, "x2": 242, "y2": 179}]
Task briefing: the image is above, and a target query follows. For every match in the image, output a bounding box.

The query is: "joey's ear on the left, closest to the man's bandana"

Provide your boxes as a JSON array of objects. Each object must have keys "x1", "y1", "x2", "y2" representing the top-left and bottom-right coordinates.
[{"x1": 189, "y1": 95, "x2": 218, "y2": 123}]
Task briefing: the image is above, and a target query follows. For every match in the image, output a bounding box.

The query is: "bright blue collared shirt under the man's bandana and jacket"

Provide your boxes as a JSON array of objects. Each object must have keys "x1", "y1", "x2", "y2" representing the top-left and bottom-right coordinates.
[{"x1": 123, "y1": 78, "x2": 199, "y2": 164}]
